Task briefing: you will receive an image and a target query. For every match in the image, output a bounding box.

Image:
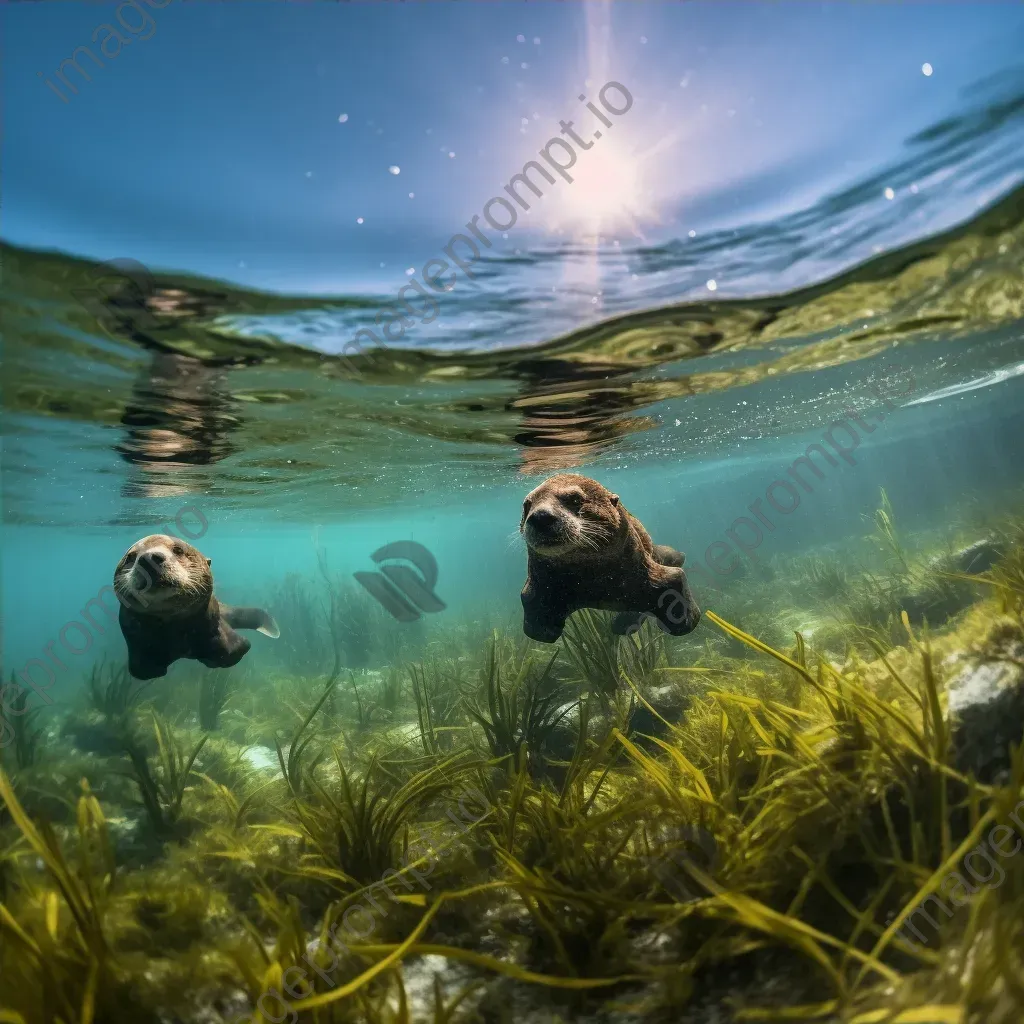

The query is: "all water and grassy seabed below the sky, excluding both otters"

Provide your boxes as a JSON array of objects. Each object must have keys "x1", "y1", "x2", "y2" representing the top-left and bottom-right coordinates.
[{"x1": 6, "y1": 2, "x2": 1024, "y2": 1024}]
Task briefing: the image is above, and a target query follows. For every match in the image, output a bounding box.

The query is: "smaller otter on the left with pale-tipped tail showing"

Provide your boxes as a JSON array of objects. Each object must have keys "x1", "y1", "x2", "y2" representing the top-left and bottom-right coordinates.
[{"x1": 114, "y1": 534, "x2": 281, "y2": 679}]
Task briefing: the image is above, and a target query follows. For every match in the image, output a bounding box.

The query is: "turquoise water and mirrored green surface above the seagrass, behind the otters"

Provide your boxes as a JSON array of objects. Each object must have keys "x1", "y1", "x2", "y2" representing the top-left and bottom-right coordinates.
[{"x1": 3, "y1": 167, "x2": 1024, "y2": 692}]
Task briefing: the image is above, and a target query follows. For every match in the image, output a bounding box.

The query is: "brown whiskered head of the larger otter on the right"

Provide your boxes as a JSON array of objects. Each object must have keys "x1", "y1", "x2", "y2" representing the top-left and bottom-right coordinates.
[{"x1": 519, "y1": 473, "x2": 624, "y2": 558}]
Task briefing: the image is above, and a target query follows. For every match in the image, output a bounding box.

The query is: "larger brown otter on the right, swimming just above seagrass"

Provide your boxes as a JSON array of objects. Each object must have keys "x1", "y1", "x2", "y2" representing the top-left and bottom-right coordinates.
[{"x1": 519, "y1": 473, "x2": 700, "y2": 643}]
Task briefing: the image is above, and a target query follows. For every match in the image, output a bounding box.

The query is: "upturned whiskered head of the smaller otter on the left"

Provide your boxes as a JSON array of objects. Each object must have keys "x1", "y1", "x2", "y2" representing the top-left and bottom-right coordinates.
[{"x1": 114, "y1": 534, "x2": 213, "y2": 616}]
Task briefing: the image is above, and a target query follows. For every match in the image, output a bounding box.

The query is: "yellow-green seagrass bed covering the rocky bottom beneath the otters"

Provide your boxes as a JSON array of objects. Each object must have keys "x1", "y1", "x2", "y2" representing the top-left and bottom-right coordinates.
[{"x1": 0, "y1": 500, "x2": 1024, "y2": 1024}]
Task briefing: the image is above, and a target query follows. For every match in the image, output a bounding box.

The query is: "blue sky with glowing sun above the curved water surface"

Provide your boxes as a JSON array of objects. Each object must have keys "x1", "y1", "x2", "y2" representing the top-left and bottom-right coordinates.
[{"x1": 2, "y1": 0, "x2": 1024, "y2": 292}]
